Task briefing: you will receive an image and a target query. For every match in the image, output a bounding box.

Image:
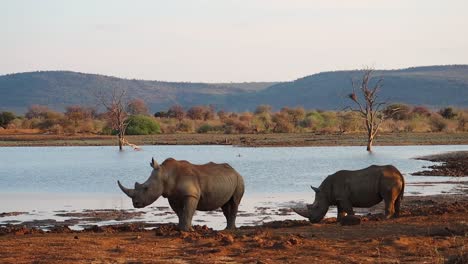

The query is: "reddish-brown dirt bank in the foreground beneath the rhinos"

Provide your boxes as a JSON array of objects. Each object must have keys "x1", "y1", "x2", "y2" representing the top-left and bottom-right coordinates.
[{"x1": 0, "y1": 195, "x2": 468, "y2": 263}]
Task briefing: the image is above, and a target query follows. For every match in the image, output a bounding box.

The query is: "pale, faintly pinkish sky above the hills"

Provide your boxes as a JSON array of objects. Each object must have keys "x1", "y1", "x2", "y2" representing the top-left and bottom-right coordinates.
[{"x1": 0, "y1": 0, "x2": 468, "y2": 82}]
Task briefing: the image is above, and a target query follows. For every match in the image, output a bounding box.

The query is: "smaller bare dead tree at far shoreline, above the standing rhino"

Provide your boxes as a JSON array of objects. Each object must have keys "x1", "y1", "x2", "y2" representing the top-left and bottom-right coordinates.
[{"x1": 97, "y1": 89, "x2": 129, "y2": 150}]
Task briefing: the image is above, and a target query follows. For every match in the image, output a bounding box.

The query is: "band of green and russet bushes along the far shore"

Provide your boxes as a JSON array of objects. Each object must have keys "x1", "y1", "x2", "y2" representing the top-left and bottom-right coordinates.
[{"x1": 0, "y1": 99, "x2": 468, "y2": 135}]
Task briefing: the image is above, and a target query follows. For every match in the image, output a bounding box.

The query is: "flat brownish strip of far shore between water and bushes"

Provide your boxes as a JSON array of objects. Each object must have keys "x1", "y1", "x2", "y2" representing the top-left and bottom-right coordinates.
[{"x1": 0, "y1": 132, "x2": 468, "y2": 147}]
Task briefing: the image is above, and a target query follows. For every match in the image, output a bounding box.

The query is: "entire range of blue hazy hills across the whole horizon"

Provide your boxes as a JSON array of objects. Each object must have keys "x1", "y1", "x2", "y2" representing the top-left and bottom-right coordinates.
[{"x1": 0, "y1": 65, "x2": 468, "y2": 113}]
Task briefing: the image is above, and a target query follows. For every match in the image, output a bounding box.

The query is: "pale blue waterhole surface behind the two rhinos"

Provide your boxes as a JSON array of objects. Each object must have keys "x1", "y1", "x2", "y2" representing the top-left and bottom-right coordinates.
[{"x1": 0, "y1": 145, "x2": 468, "y2": 229}]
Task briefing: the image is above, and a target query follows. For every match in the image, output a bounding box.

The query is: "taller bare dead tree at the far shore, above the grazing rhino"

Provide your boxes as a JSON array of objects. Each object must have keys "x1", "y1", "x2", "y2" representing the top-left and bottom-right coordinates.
[{"x1": 348, "y1": 68, "x2": 398, "y2": 152}]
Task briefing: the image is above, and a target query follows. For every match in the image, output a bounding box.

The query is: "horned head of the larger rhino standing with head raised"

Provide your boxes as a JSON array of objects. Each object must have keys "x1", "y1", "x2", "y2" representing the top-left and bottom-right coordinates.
[{"x1": 117, "y1": 159, "x2": 164, "y2": 208}]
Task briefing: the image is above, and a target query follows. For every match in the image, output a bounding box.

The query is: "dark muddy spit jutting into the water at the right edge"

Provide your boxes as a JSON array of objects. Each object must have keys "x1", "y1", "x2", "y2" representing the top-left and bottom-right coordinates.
[{"x1": 413, "y1": 151, "x2": 468, "y2": 177}]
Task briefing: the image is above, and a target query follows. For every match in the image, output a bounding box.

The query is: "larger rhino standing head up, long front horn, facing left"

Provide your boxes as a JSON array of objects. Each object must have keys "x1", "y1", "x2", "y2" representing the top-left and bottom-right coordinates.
[{"x1": 117, "y1": 158, "x2": 244, "y2": 231}]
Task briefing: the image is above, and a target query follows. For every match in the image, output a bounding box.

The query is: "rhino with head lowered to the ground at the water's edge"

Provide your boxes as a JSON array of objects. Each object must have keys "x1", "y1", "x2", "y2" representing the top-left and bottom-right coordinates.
[{"x1": 293, "y1": 165, "x2": 405, "y2": 223}]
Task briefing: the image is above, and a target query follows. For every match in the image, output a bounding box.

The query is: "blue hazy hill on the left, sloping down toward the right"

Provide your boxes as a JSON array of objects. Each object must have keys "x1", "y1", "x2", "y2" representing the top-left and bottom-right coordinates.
[{"x1": 0, "y1": 71, "x2": 275, "y2": 113}]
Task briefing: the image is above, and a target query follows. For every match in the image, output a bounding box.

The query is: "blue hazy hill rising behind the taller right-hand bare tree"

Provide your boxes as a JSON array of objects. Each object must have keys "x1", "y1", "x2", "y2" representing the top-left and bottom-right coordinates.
[{"x1": 227, "y1": 65, "x2": 468, "y2": 110}]
